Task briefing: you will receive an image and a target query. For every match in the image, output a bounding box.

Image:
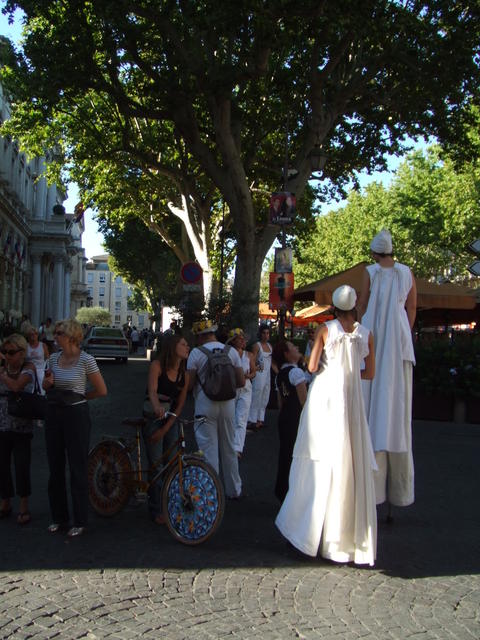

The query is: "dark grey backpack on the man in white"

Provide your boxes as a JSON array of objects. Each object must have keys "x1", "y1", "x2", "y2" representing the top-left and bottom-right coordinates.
[{"x1": 198, "y1": 345, "x2": 237, "y2": 401}]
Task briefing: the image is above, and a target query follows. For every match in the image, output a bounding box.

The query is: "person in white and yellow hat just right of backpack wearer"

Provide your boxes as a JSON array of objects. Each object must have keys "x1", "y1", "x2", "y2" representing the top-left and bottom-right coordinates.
[{"x1": 227, "y1": 327, "x2": 256, "y2": 458}]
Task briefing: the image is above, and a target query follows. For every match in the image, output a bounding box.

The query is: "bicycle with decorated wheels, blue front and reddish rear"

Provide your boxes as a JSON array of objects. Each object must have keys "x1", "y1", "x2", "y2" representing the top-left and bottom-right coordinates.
[{"x1": 88, "y1": 412, "x2": 225, "y2": 545}]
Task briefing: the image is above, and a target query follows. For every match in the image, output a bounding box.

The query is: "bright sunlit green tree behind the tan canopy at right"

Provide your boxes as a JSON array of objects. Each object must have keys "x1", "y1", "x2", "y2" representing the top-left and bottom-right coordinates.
[{"x1": 295, "y1": 147, "x2": 480, "y2": 285}]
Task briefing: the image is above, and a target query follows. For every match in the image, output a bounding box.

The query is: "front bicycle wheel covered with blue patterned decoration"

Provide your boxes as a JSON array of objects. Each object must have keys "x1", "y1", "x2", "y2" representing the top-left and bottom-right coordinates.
[{"x1": 162, "y1": 457, "x2": 225, "y2": 545}]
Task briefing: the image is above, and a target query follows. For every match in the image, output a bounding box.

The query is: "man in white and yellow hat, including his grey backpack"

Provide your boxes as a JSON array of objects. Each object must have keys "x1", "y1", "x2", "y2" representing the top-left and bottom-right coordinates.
[{"x1": 187, "y1": 320, "x2": 245, "y2": 499}]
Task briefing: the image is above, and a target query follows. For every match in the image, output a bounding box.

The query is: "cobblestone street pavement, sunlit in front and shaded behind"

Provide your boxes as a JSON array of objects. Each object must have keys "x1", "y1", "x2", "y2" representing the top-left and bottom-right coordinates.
[{"x1": 0, "y1": 359, "x2": 480, "y2": 640}]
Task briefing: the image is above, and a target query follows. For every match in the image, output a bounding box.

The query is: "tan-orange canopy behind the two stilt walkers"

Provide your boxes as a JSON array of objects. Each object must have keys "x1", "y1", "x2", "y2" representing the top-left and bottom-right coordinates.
[{"x1": 293, "y1": 262, "x2": 480, "y2": 325}]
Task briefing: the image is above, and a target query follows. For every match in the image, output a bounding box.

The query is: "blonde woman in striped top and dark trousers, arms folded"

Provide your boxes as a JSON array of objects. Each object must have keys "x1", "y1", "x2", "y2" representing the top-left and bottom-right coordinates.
[{"x1": 43, "y1": 320, "x2": 107, "y2": 538}]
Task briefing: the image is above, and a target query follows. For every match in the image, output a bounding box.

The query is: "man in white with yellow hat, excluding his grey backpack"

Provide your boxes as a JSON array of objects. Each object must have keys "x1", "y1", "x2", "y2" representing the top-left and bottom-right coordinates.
[{"x1": 187, "y1": 320, "x2": 245, "y2": 498}]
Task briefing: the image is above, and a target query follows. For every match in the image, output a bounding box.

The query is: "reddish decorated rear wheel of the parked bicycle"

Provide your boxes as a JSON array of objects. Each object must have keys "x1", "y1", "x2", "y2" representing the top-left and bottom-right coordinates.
[{"x1": 88, "y1": 440, "x2": 133, "y2": 516}]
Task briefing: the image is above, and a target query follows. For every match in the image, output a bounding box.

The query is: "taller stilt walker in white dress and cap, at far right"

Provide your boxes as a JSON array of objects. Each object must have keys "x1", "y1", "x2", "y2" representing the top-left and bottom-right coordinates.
[{"x1": 357, "y1": 229, "x2": 417, "y2": 521}]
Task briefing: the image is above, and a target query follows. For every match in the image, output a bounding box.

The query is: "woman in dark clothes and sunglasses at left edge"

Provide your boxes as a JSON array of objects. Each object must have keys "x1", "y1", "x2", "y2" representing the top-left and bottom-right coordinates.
[{"x1": 0, "y1": 334, "x2": 35, "y2": 525}]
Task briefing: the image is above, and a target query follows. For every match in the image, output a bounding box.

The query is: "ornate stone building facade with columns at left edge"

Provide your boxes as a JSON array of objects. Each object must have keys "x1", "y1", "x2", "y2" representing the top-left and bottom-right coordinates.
[{"x1": 0, "y1": 86, "x2": 87, "y2": 326}]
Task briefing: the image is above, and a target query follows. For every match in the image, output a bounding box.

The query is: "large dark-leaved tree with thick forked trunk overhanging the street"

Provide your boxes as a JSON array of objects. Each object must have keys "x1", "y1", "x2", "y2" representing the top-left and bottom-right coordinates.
[{"x1": 1, "y1": 0, "x2": 480, "y2": 336}]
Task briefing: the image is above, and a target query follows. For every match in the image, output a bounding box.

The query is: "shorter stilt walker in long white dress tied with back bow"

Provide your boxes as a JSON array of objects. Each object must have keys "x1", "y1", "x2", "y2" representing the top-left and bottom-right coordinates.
[{"x1": 275, "y1": 285, "x2": 377, "y2": 565}]
